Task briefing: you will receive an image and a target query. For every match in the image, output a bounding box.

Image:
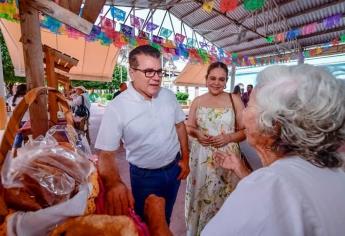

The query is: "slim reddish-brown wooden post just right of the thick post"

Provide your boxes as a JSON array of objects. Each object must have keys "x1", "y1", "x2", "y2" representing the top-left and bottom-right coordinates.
[{"x1": 44, "y1": 46, "x2": 58, "y2": 124}]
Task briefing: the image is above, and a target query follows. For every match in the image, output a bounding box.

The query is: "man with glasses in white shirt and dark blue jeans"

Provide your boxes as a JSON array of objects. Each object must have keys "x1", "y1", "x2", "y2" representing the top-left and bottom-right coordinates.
[{"x1": 95, "y1": 45, "x2": 189, "y2": 222}]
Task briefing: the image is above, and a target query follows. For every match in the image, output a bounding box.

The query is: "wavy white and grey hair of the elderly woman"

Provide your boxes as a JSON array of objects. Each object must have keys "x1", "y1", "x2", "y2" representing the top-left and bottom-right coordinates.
[{"x1": 255, "y1": 64, "x2": 345, "y2": 167}]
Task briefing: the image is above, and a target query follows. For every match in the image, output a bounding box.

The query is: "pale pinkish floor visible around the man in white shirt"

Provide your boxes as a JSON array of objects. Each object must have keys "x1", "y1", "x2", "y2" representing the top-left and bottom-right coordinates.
[{"x1": 90, "y1": 103, "x2": 186, "y2": 236}]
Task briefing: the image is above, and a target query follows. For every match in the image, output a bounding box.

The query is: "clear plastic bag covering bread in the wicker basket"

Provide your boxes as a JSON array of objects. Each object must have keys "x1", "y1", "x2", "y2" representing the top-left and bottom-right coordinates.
[{"x1": 1, "y1": 126, "x2": 93, "y2": 210}]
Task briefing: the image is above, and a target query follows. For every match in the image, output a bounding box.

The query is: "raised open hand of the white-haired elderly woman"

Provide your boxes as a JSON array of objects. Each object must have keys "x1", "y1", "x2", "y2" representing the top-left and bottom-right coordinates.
[{"x1": 213, "y1": 151, "x2": 250, "y2": 179}]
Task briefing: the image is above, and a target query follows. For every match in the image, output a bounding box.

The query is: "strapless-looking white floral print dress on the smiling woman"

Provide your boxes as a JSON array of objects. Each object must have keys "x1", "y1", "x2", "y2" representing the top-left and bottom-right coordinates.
[{"x1": 185, "y1": 107, "x2": 240, "y2": 236}]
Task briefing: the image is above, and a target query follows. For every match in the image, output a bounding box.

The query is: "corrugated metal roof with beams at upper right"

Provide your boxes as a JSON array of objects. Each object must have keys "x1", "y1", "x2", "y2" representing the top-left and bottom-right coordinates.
[{"x1": 107, "y1": 0, "x2": 345, "y2": 56}]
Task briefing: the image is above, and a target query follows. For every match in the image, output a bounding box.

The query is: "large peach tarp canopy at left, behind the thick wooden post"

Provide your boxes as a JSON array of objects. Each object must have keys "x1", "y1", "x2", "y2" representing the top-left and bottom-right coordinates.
[{"x1": 0, "y1": 19, "x2": 120, "y2": 82}]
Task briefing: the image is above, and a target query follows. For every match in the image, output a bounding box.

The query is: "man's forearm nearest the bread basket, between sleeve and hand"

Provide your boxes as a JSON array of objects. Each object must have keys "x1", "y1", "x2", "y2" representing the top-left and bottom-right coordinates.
[{"x1": 98, "y1": 151, "x2": 122, "y2": 189}]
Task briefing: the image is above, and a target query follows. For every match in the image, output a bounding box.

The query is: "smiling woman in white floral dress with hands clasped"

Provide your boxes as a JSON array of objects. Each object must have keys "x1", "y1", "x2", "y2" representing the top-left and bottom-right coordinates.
[{"x1": 185, "y1": 62, "x2": 245, "y2": 236}]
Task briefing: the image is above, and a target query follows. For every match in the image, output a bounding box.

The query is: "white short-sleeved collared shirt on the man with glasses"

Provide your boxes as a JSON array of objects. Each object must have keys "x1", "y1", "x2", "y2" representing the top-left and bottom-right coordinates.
[{"x1": 95, "y1": 84, "x2": 185, "y2": 169}]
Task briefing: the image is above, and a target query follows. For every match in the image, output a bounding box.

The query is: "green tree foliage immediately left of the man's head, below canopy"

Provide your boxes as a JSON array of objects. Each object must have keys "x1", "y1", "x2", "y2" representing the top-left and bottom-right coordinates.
[{"x1": 72, "y1": 65, "x2": 127, "y2": 91}]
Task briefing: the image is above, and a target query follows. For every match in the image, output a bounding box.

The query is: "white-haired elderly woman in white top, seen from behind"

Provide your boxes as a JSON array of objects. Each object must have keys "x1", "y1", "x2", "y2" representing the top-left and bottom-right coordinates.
[{"x1": 202, "y1": 65, "x2": 345, "y2": 236}]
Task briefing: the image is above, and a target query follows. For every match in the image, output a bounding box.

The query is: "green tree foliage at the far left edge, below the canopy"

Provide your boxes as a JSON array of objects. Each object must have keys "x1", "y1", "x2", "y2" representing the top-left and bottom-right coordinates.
[{"x1": 0, "y1": 31, "x2": 25, "y2": 87}]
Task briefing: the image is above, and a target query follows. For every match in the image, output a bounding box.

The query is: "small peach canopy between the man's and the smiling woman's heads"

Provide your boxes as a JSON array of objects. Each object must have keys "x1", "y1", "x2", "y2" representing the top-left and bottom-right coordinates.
[{"x1": 175, "y1": 62, "x2": 209, "y2": 87}]
